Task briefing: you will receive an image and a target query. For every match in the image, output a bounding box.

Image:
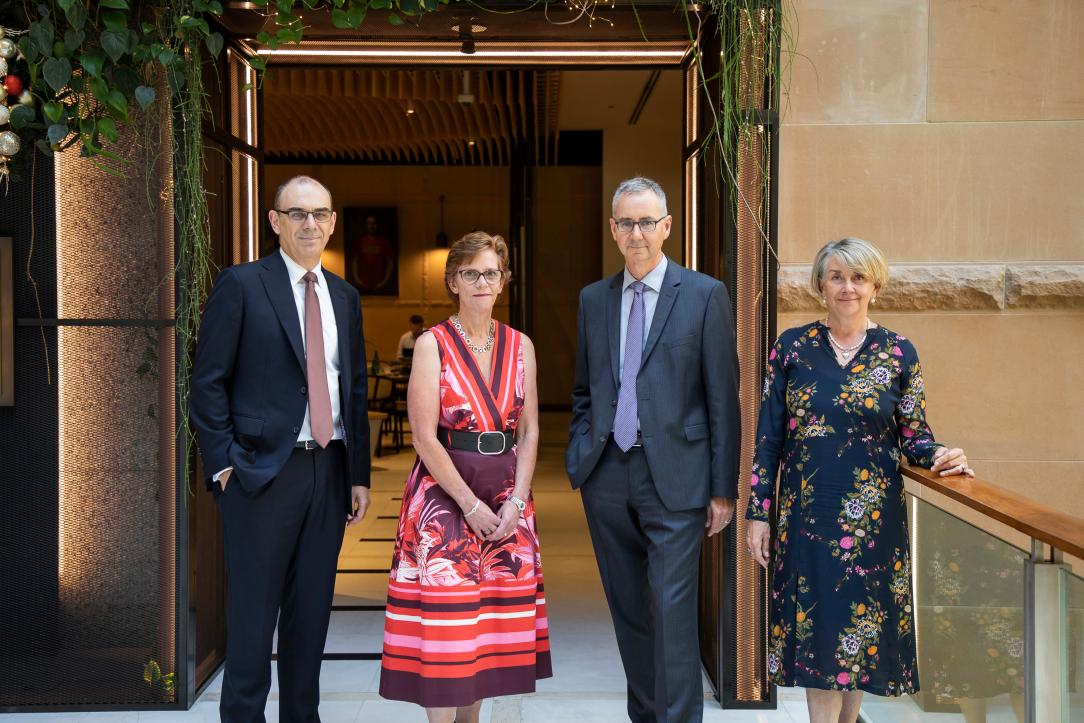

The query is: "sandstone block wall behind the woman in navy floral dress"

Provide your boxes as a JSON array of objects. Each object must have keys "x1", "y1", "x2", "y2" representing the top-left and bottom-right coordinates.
[{"x1": 777, "y1": 0, "x2": 1084, "y2": 516}]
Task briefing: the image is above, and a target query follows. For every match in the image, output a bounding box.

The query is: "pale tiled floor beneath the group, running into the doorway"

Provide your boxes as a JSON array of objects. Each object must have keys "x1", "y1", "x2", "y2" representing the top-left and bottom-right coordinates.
[{"x1": 0, "y1": 414, "x2": 984, "y2": 723}]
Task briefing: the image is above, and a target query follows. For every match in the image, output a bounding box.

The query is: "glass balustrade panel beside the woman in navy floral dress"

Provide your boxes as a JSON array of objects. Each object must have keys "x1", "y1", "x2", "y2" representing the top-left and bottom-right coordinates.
[{"x1": 862, "y1": 495, "x2": 1031, "y2": 723}]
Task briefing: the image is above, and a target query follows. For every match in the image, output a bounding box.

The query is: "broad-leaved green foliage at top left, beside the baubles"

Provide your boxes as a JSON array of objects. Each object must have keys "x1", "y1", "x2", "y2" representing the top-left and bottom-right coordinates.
[{"x1": 12, "y1": 0, "x2": 461, "y2": 164}]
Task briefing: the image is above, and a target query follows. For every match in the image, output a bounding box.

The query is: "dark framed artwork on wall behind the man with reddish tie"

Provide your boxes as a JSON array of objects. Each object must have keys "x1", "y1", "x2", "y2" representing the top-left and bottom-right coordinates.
[{"x1": 343, "y1": 206, "x2": 399, "y2": 296}]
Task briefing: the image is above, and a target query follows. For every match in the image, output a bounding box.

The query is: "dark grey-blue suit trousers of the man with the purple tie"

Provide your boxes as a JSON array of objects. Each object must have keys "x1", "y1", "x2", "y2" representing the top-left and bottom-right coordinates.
[{"x1": 581, "y1": 440, "x2": 707, "y2": 723}]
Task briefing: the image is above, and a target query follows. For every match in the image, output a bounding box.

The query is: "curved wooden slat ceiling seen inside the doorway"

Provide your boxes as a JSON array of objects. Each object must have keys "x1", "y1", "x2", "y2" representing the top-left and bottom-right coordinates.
[{"x1": 263, "y1": 67, "x2": 560, "y2": 165}]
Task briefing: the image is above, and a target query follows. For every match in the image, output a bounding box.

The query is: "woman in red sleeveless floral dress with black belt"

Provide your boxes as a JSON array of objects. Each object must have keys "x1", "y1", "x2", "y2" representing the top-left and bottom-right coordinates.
[{"x1": 380, "y1": 231, "x2": 552, "y2": 723}]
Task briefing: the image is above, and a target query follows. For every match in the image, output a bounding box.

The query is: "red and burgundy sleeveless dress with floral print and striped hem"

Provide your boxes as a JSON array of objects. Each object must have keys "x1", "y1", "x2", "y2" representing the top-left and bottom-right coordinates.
[{"x1": 380, "y1": 321, "x2": 553, "y2": 708}]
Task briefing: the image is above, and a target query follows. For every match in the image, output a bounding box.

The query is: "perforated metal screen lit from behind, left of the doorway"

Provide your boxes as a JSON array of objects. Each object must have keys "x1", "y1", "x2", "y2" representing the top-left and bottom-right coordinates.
[{"x1": 0, "y1": 108, "x2": 176, "y2": 709}]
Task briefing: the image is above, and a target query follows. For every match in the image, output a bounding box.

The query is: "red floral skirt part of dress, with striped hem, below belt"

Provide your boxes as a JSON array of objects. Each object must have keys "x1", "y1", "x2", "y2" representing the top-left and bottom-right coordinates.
[{"x1": 380, "y1": 450, "x2": 553, "y2": 708}]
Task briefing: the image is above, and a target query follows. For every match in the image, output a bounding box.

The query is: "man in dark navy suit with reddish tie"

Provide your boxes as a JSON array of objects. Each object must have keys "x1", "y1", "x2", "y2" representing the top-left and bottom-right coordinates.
[{"x1": 190, "y1": 176, "x2": 370, "y2": 723}]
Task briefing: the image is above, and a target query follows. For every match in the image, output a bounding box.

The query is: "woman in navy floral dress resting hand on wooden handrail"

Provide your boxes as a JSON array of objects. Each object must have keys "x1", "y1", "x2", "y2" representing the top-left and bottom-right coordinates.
[{"x1": 746, "y1": 238, "x2": 973, "y2": 723}]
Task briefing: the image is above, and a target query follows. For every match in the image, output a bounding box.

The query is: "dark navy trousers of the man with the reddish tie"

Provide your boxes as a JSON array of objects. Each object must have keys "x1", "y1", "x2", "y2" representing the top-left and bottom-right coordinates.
[{"x1": 216, "y1": 441, "x2": 347, "y2": 723}]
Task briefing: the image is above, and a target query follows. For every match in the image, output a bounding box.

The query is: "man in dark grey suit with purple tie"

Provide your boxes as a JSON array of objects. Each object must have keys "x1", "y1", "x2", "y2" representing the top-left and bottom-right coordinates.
[{"x1": 565, "y1": 178, "x2": 740, "y2": 723}]
